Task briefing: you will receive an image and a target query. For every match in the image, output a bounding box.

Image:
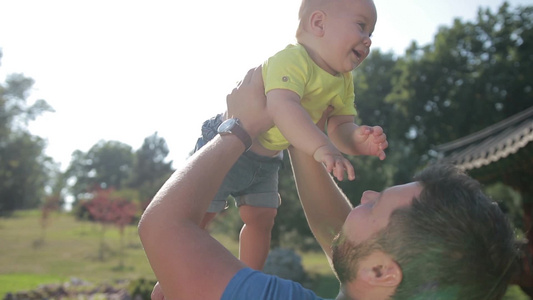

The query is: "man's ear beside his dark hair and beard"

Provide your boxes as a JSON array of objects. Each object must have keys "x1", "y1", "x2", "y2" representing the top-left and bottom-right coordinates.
[{"x1": 357, "y1": 251, "x2": 403, "y2": 287}]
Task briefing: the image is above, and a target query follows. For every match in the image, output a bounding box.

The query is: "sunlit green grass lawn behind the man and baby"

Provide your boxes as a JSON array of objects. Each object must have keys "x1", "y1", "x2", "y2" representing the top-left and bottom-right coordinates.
[{"x1": 0, "y1": 211, "x2": 528, "y2": 300}]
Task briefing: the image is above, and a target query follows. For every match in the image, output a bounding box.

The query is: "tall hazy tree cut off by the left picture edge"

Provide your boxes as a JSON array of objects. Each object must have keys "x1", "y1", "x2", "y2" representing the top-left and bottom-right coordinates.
[{"x1": 0, "y1": 52, "x2": 53, "y2": 216}]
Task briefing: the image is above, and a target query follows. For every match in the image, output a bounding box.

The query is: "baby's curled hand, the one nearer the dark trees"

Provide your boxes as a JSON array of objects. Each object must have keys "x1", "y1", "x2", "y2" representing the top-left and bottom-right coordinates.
[{"x1": 353, "y1": 125, "x2": 389, "y2": 160}]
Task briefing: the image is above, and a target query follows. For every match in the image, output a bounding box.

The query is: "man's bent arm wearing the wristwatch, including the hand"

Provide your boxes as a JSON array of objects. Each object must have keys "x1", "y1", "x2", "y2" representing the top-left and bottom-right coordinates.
[{"x1": 139, "y1": 71, "x2": 271, "y2": 300}]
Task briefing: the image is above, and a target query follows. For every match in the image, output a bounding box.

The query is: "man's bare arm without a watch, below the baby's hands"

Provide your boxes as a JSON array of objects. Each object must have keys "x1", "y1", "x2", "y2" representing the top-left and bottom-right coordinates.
[{"x1": 289, "y1": 147, "x2": 352, "y2": 259}]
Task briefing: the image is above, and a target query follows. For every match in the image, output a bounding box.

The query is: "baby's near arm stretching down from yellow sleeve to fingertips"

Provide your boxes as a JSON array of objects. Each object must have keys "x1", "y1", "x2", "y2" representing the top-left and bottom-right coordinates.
[{"x1": 267, "y1": 89, "x2": 355, "y2": 180}]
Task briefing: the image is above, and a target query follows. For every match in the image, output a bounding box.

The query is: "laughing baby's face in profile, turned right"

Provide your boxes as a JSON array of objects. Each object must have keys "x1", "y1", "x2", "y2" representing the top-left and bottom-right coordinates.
[{"x1": 320, "y1": 0, "x2": 377, "y2": 75}]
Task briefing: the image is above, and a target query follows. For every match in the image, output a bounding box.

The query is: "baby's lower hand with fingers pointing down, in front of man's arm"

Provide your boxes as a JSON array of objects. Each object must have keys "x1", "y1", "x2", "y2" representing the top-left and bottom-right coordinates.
[{"x1": 313, "y1": 144, "x2": 355, "y2": 181}]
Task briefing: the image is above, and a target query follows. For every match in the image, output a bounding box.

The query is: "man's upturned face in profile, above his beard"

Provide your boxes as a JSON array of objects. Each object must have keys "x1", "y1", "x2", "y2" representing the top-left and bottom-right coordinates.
[{"x1": 342, "y1": 182, "x2": 422, "y2": 245}]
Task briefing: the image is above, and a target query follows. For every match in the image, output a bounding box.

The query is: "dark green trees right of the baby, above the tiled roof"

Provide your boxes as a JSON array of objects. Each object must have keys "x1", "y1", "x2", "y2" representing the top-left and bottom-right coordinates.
[{"x1": 348, "y1": 3, "x2": 533, "y2": 187}]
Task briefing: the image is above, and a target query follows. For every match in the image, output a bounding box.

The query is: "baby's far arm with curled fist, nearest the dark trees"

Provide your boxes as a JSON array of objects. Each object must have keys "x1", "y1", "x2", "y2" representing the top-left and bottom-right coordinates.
[{"x1": 328, "y1": 116, "x2": 388, "y2": 160}]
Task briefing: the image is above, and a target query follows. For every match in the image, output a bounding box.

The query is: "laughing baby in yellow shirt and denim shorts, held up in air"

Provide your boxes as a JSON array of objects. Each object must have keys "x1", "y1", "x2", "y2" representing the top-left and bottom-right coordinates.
[{"x1": 196, "y1": 0, "x2": 387, "y2": 269}]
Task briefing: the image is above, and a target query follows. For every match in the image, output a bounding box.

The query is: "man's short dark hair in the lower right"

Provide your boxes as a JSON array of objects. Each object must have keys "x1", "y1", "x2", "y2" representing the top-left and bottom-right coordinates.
[{"x1": 332, "y1": 165, "x2": 518, "y2": 300}]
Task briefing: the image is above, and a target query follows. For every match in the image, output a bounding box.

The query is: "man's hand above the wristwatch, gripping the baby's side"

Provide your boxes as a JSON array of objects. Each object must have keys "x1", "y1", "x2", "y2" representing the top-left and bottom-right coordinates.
[{"x1": 226, "y1": 67, "x2": 274, "y2": 138}]
